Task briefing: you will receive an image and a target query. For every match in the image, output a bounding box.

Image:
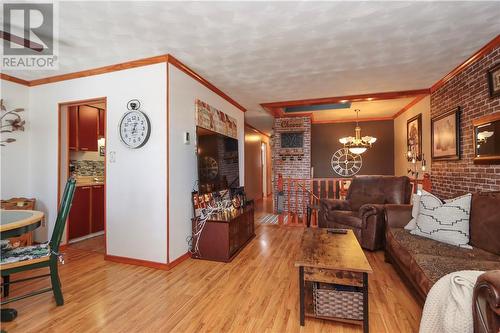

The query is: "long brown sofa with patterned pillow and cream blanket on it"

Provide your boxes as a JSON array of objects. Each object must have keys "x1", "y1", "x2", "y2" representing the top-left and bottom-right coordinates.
[{"x1": 385, "y1": 193, "x2": 500, "y2": 332}]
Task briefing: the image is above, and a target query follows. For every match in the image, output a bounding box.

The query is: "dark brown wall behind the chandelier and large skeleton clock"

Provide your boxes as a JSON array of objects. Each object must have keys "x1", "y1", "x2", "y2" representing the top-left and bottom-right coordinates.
[{"x1": 311, "y1": 120, "x2": 394, "y2": 178}]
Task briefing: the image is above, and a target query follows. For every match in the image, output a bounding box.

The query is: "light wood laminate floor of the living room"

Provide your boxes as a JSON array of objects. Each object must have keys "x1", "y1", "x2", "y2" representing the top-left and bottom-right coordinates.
[{"x1": 2, "y1": 198, "x2": 421, "y2": 333}]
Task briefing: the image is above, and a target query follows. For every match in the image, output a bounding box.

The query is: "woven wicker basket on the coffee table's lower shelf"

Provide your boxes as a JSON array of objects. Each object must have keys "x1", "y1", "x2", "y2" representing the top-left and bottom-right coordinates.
[{"x1": 313, "y1": 283, "x2": 363, "y2": 320}]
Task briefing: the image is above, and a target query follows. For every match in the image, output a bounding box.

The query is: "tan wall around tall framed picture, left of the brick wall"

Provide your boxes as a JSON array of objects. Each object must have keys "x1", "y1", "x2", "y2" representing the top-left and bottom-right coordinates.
[{"x1": 394, "y1": 96, "x2": 431, "y2": 178}]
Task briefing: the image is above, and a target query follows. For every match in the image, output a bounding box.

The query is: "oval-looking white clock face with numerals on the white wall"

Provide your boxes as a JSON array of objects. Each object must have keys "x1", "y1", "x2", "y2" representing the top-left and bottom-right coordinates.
[{"x1": 120, "y1": 110, "x2": 151, "y2": 148}]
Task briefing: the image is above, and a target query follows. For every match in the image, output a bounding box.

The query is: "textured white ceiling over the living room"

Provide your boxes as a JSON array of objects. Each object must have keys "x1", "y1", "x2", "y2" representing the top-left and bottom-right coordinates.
[{"x1": 4, "y1": 2, "x2": 500, "y2": 134}]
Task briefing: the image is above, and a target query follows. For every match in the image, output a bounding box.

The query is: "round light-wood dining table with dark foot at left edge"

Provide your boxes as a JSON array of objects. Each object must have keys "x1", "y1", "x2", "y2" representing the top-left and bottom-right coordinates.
[{"x1": 0, "y1": 209, "x2": 45, "y2": 322}]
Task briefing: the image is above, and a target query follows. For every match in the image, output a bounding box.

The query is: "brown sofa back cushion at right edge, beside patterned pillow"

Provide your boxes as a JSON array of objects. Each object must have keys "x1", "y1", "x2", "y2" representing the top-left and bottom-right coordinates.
[{"x1": 470, "y1": 192, "x2": 500, "y2": 255}]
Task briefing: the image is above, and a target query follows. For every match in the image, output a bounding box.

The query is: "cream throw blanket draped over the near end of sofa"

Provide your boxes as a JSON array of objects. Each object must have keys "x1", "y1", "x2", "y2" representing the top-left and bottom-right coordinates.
[{"x1": 419, "y1": 271, "x2": 484, "y2": 333}]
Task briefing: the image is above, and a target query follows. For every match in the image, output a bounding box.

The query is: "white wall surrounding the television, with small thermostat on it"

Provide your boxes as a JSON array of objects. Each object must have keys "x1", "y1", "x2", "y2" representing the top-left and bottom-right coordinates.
[{"x1": 169, "y1": 65, "x2": 245, "y2": 261}]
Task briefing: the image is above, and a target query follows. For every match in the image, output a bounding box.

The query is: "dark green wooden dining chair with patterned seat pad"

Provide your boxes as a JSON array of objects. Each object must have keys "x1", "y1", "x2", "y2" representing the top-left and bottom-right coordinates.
[{"x1": 0, "y1": 178, "x2": 76, "y2": 305}]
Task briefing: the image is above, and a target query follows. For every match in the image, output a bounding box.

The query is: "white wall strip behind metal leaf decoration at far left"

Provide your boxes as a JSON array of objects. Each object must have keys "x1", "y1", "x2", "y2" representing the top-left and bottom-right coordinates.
[{"x1": 0, "y1": 80, "x2": 30, "y2": 199}]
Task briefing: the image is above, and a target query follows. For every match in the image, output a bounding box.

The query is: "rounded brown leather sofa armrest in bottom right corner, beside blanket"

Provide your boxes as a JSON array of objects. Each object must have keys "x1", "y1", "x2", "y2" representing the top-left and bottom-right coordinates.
[{"x1": 472, "y1": 270, "x2": 500, "y2": 333}]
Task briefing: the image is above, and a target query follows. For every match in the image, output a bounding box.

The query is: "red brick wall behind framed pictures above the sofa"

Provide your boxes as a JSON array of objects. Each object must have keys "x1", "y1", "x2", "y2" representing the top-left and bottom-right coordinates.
[{"x1": 431, "y1": 47, "x2": 500, "y2": 198}]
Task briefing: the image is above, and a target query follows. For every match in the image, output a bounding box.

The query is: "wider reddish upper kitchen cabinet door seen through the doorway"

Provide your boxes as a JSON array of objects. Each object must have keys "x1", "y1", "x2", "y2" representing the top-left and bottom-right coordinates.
[{"x1": 78, "y1": 105, "x2": 99, "y2": 151}]
